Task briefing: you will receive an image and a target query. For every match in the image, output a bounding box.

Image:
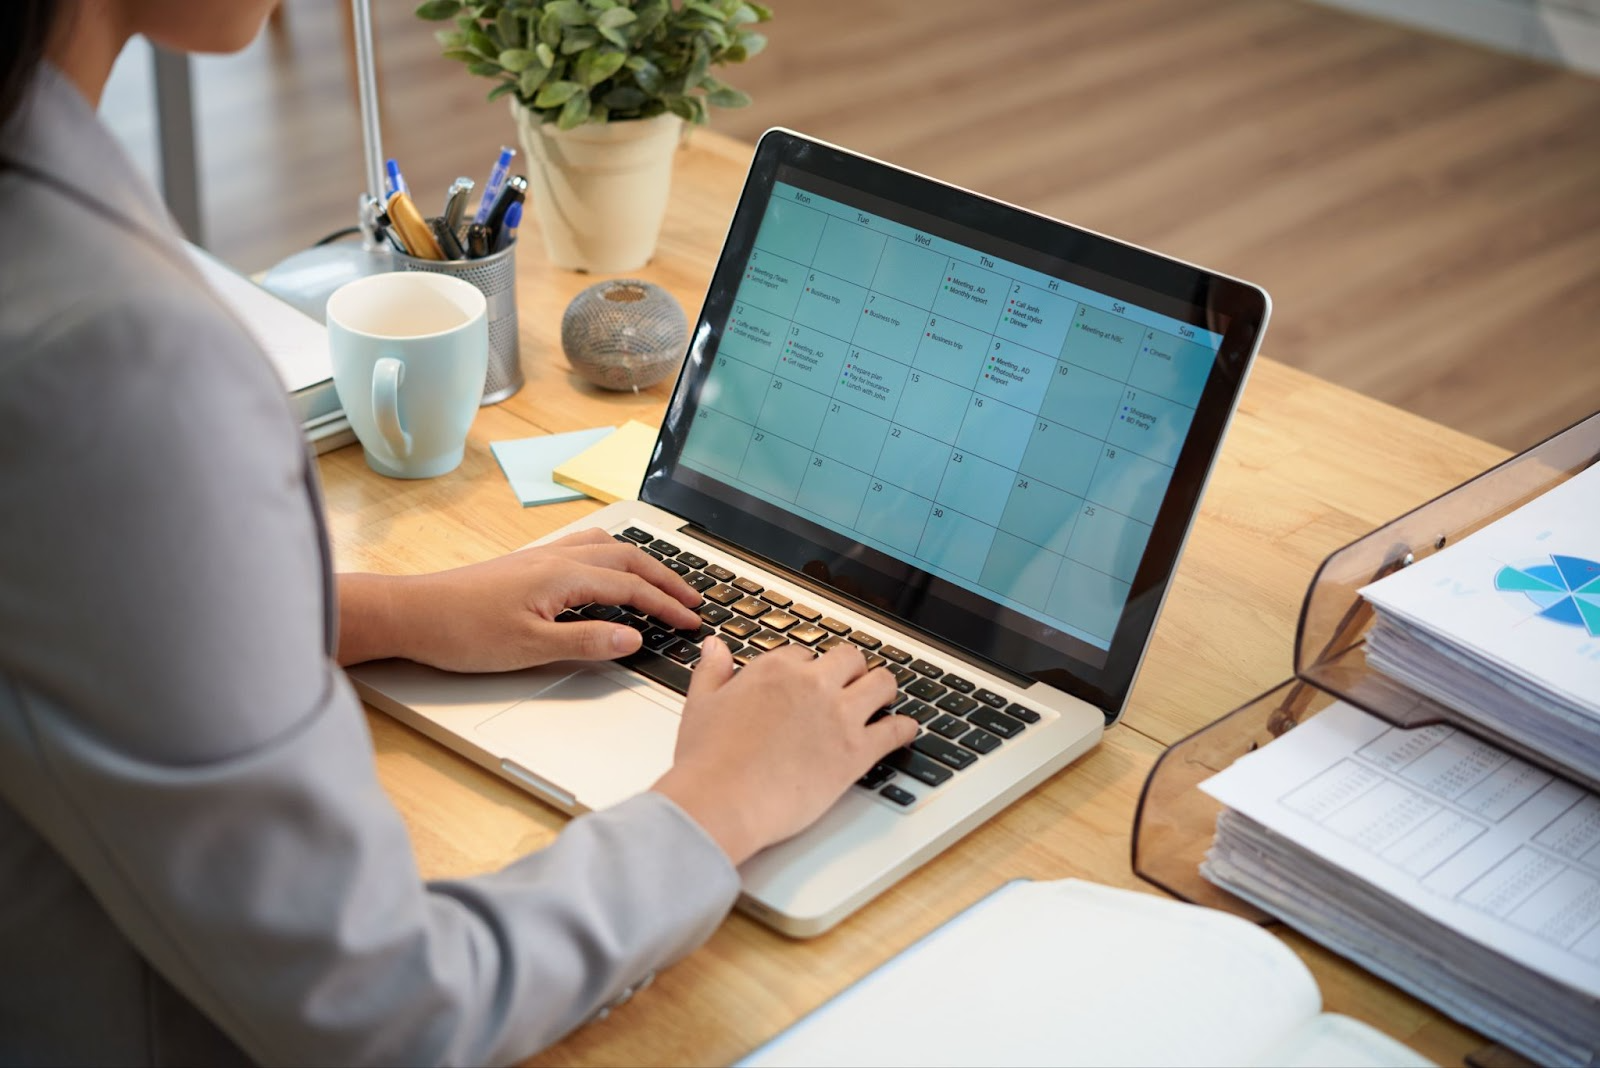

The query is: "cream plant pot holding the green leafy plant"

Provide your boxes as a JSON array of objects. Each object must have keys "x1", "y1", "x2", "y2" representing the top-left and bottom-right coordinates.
[{"x1": 510, "y1": 99, "x2": 683, "y2": 273}]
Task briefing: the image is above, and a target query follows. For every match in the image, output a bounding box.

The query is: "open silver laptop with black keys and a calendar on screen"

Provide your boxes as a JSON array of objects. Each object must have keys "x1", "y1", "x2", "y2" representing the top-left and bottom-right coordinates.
[{"x1": 350, "y1": 130, "x2": 1269, "y2": 937}]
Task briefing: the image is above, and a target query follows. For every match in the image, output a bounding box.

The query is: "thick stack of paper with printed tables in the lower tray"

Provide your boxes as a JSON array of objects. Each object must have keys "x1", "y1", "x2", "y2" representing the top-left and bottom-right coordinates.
[{"x1": 1202, "y1": 703, "x2": 1600, "y2": 1065}]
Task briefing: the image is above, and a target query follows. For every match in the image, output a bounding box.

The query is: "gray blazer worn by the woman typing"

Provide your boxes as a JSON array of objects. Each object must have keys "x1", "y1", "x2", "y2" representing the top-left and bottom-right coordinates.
[{"x1": 0, "y1": 69, "x2": 739, "y2": 1065}]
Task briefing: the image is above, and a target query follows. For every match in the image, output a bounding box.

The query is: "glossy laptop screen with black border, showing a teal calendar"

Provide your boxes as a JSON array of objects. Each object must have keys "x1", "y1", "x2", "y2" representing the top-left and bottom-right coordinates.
[{"x1": 645, "y1": 134, "x2": 1253, "y2": 713}]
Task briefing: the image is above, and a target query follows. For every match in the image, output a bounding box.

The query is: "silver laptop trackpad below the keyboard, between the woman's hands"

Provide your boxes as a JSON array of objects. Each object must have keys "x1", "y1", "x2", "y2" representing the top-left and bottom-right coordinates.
[{"x1": 477, "y1": 665, "x2": 678, "y2": 809}]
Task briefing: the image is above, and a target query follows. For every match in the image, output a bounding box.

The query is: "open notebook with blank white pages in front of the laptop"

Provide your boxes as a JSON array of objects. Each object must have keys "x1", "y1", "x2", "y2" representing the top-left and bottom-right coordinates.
[{"x1": 741, "y1": 879, "x2": 1432, "y2": 1066}]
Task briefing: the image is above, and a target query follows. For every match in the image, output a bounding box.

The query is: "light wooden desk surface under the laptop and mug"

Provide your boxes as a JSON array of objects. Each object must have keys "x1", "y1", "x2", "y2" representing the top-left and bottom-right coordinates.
[{"x1": 322, "y1": 131, "x2": 1504, "y2": 1065}]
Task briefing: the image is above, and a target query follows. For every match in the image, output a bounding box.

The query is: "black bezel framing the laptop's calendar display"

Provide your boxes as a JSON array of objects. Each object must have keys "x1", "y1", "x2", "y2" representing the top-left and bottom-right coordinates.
[{"x1": 640, "y1": 130, "x2": 1269, "y2": 721}]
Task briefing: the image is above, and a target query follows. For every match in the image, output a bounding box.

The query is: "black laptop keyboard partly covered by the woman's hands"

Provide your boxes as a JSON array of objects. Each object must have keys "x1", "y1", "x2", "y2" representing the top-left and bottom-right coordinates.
[{"x1": 557, "y1": 526, "x2": 1040, "y2": 809}]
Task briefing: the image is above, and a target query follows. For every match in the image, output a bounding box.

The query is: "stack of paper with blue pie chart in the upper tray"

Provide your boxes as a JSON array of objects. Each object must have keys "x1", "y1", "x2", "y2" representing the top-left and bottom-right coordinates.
[{"x1": 1362, "y1": 465, "x2": 1600, "y2": 785}]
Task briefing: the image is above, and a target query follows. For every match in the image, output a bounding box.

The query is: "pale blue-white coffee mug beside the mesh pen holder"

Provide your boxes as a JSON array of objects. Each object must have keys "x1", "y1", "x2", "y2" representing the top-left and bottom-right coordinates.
[{"x1": 328, "y1": 272, "x2": 490, "y2": 478}]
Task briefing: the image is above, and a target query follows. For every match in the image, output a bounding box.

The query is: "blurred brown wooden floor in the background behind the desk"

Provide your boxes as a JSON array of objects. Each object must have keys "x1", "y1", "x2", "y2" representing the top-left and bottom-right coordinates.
[{"x1": 104, "y1": 0, "x2": 1600, "y2": 448}]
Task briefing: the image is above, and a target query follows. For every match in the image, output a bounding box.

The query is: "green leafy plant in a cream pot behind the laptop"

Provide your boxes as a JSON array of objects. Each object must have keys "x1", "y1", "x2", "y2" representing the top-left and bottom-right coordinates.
[{"x1": 416, "y1": 0, "x2": 771, "y2": 272}]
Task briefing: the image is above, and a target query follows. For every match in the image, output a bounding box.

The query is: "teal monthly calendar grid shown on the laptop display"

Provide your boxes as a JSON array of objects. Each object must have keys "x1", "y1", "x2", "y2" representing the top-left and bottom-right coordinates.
[{"x1": 685, "y1": 181, "x2": 1214, "y2": 648}]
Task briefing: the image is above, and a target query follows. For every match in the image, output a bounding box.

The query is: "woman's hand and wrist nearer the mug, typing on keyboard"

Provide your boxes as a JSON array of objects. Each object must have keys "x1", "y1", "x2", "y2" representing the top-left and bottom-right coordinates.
[{"x1": 339, "y1": 529, "x2": 701, "y2": 671}]
